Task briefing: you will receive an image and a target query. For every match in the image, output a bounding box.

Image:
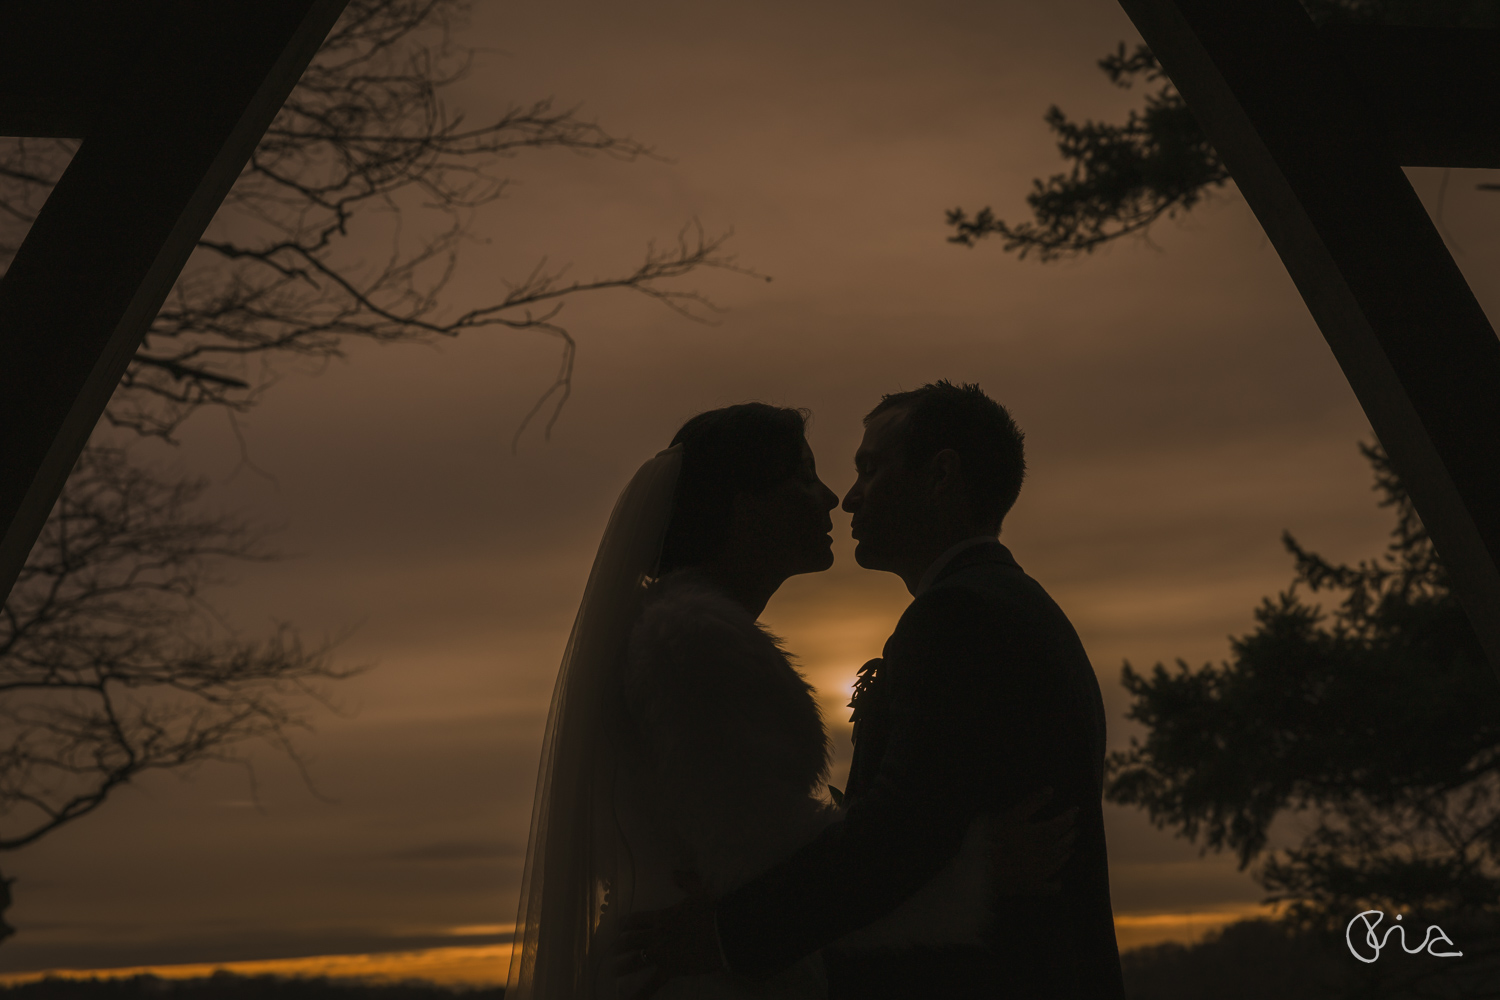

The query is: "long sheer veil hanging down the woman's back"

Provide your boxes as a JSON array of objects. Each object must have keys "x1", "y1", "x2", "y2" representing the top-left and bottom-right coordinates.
[{"x1": 506, "y1": 445, "x2": 683, "y2": 1000}]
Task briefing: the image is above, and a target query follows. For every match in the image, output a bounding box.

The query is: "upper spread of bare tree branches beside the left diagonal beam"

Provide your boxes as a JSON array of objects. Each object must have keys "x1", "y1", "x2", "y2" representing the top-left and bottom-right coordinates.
[{"x1": 0, "y1": 0, "x2": 749, "y2": 438}]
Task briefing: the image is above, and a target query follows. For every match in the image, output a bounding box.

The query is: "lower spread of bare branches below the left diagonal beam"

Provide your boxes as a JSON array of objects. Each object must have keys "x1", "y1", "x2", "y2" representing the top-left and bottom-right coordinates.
[{"x1": 0, "y1": 447, "x2": 345, "y2": 937}]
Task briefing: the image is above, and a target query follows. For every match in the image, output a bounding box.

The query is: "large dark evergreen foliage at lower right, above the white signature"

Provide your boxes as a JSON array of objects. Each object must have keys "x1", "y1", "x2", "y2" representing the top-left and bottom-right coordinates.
[{"x1": 1106, "y1": 447, "x2": 1500, "y2": 925}]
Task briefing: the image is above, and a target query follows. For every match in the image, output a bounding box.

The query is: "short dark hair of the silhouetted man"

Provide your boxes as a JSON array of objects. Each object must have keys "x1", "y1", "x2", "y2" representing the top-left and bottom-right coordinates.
[{"x1": 864, "y1": 379, "x2": 1026, "y2": 528}]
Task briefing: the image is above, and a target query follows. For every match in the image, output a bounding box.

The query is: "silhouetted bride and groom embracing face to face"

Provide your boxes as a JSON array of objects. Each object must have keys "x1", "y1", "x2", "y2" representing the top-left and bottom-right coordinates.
[{"x1": 506, "y1": 382, "x2": 1124, "y2": 1000}]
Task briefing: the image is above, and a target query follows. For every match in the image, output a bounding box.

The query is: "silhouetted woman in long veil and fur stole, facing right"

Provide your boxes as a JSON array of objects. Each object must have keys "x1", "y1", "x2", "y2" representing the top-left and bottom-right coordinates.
[{"x1": 506, "y1": 403, "x2": 1067, "y2": 1000}]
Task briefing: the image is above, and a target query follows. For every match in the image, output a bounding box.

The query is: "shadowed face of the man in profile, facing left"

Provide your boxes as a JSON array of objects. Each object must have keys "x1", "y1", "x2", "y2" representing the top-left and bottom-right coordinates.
[{"x1": 843, "y1": 409, "x2": 929, "y2": 573}]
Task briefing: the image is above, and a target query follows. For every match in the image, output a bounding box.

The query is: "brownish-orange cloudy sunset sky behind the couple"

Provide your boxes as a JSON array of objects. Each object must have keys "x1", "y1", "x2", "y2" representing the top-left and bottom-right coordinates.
[{"x1": 0, "y1": 0, "x2": 1500, "y2": 982}]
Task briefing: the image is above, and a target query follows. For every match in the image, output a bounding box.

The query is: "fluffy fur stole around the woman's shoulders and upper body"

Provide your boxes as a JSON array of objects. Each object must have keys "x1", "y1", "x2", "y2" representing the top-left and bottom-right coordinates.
[{"x1": 626, "y1": 570, "x2": 839, "y2": 894}]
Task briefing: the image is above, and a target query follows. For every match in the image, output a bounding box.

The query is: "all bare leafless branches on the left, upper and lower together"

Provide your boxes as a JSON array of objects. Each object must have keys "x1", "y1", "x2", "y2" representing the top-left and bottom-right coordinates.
[{"x1": 0, "y1": 0, "x2": 750, "y2": 939}]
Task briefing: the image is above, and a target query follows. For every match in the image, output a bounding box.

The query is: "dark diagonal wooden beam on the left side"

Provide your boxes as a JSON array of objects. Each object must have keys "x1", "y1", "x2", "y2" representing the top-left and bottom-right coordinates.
[{"x1": 0, "y1": 0, "x2": 347, "y2": 600}]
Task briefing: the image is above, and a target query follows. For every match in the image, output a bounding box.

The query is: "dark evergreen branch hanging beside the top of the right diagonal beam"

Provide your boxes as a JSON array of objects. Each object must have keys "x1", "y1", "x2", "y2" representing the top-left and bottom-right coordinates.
[{"x1": 948, "y1": 0, "x2": 1500, "y2": 261}]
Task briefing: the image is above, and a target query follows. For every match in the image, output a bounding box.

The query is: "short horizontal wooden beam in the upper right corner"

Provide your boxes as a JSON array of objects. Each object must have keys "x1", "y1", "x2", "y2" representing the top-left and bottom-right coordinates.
[{"x1": 1320, "y1": 24, "x2": 1500, "y2": 166}]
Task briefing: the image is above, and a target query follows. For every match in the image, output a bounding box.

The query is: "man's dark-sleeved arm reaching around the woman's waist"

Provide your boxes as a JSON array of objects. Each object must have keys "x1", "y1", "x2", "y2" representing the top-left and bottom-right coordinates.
[{"x1": 716, "y1": 588, "x2": 1040, "y2": 976}]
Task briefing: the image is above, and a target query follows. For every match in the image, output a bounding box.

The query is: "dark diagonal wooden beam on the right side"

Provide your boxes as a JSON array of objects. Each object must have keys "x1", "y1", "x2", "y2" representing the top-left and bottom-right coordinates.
[{"x1": 1121, "y1": 0, "x2": 1500, "y2": 672}]
